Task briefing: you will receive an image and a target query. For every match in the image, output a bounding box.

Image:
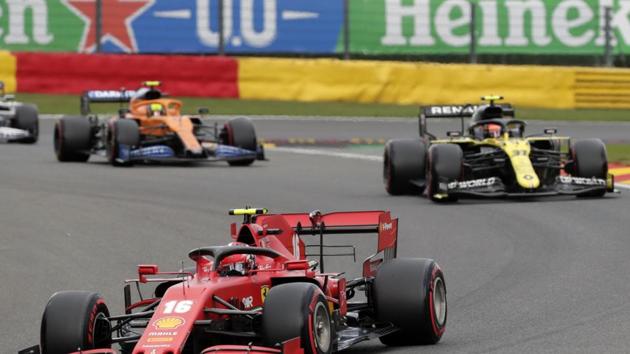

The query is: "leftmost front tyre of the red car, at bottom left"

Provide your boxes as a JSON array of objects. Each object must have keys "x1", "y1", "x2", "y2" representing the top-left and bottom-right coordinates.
[{"x1": 40, "y1": 291, "x2": 112, "y2": 354}]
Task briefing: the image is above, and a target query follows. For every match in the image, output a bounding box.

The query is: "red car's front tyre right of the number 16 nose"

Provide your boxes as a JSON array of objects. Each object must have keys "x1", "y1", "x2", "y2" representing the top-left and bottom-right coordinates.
[{"x1": 262, "y1": 283, "x2": 335, "y2": 354}]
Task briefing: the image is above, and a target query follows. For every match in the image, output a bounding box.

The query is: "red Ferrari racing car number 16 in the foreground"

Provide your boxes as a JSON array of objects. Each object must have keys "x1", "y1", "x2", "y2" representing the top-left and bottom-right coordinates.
[{"x1": 23, "y1": 208, "x2": 447, "y2": 354}]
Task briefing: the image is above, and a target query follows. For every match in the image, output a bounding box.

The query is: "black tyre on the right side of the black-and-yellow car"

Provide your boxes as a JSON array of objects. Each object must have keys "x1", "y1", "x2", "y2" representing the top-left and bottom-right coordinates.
[{"x1": 571, "y1": 139, "x2": 608, "y2": 197}]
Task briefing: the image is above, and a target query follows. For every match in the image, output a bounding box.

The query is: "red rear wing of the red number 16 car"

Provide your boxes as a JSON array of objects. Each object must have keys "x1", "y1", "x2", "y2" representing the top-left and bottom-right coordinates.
[{"x1": 255, "y1": 210, "x2": 398, "y2": 277}]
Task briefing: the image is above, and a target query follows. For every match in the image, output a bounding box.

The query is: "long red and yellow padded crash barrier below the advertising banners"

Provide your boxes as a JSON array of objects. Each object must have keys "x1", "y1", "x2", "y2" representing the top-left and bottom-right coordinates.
[{"x1": 0, "y1": 53, "x2": 630, "y2": 108}]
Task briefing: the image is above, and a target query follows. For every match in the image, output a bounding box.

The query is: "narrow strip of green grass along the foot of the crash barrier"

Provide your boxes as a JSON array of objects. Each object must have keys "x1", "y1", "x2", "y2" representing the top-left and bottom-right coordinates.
[{"x1": 17, "y1": 93, "x2": 630, "y2": 121}]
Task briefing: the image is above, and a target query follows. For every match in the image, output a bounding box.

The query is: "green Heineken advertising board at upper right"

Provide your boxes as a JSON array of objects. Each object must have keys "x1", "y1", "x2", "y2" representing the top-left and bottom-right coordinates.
[{"x1": 350, "y1": 0, "x2": 630, "y2": 55}]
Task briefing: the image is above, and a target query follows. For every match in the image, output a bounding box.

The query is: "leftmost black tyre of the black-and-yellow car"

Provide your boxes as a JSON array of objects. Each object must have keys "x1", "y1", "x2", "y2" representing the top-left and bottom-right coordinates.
[{"x1": 383, "y1": 139, "x2": 427, "y2": 195}]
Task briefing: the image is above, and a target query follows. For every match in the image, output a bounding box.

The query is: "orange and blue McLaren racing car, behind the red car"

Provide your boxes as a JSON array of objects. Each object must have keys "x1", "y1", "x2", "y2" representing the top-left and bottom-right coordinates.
[{"x1": 54, "y1": 81, "x2": 264, "y2": 166}]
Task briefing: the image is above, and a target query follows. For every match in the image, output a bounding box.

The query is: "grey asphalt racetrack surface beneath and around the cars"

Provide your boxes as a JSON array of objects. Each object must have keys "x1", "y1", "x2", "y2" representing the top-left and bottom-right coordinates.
[{"x1": 0, "y1": 119, "x2": 630, "y2": 353}]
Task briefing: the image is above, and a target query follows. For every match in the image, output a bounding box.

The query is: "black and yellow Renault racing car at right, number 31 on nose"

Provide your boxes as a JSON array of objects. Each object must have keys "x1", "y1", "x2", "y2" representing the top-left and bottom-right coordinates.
[{"x1": 383, "y1": 96, "x2": 614, "y2": 201}]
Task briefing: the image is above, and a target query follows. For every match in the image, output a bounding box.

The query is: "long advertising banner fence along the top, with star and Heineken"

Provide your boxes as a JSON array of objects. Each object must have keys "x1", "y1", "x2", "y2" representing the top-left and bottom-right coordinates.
[{"x1": 0, "y1": 0, "x2": 630, "y2": 66}]
